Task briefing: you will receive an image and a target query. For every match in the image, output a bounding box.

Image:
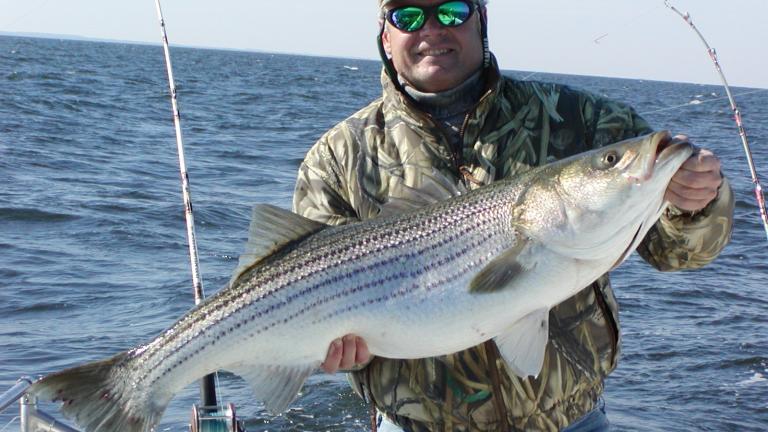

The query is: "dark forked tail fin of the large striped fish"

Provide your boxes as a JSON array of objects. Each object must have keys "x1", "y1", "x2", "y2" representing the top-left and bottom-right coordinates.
[{"x1": 30, "y1": 352, "x2": 168, "y2": 432}]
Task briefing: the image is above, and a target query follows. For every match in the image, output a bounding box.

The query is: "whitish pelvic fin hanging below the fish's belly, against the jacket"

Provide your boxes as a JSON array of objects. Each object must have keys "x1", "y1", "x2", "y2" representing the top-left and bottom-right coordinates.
[{"x1": 493, "y1": 308, "x2": 549, "y2": 378}]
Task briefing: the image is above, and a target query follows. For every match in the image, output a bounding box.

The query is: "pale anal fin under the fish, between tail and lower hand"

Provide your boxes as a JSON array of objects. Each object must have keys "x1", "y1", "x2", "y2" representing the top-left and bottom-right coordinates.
[{"x1": 227, "y1": 363, "x2": 318, "y2": 414}]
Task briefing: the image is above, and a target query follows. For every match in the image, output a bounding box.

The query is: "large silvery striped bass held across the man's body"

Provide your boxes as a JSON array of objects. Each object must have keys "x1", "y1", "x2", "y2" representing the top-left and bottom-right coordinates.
[{"x1": 32, "y1": 132, "x2": 693, "y2": 432}]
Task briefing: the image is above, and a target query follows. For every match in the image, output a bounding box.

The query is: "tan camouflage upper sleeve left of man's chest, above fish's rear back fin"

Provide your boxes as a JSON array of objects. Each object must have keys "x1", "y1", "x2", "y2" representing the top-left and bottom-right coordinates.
[{"x1": 293, "y1": 126, "x2": 359, "y2": 225}]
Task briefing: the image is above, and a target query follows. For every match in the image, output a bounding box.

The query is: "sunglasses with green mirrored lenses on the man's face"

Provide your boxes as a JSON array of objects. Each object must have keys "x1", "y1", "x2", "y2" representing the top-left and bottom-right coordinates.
[{"x1": 387, "y1": 1, "x2": 475, "y2": 33}]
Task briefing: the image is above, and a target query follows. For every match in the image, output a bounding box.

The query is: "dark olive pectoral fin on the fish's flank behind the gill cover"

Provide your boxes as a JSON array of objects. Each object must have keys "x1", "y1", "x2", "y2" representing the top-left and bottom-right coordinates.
[{"x1": 469, "y1": 235, "x2": 531, "y2": 293}]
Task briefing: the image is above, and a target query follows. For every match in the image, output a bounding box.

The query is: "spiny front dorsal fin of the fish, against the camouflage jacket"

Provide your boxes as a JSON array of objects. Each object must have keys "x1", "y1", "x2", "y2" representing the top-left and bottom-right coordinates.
[{"x1": 378, "y1": 167, "x2": 467, "y2": 217}]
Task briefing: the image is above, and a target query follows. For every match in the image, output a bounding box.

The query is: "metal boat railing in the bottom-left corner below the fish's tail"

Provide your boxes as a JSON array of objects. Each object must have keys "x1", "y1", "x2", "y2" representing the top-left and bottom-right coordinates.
[{"x1": 0, "y1": 376, "x2": 80, "y2": 432}]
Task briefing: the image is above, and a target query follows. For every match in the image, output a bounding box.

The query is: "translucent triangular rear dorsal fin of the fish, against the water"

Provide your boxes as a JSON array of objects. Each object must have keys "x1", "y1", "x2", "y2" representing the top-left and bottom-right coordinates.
[{"x1": 230, "y1": 204, "x2": 328, "y2": 285}]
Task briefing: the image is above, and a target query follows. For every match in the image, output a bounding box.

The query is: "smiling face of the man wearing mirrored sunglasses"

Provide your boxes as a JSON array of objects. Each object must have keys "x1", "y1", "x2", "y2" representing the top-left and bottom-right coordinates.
[{"x1": 382, "y1": 0, "x2": 485, "y2": 93}]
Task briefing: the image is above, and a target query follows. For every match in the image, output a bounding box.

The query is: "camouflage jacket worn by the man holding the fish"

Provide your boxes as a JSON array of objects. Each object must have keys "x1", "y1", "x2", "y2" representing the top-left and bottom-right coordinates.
[{"x1": 293, "y1": 61, "x2": 733, "y2": 431}]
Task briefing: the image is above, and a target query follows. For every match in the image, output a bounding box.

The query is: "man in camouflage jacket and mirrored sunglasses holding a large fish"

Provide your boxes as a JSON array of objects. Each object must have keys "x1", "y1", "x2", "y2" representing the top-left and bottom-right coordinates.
[{"x1": 294, "y1": 0, "x2": 733, "y2": 431}]
